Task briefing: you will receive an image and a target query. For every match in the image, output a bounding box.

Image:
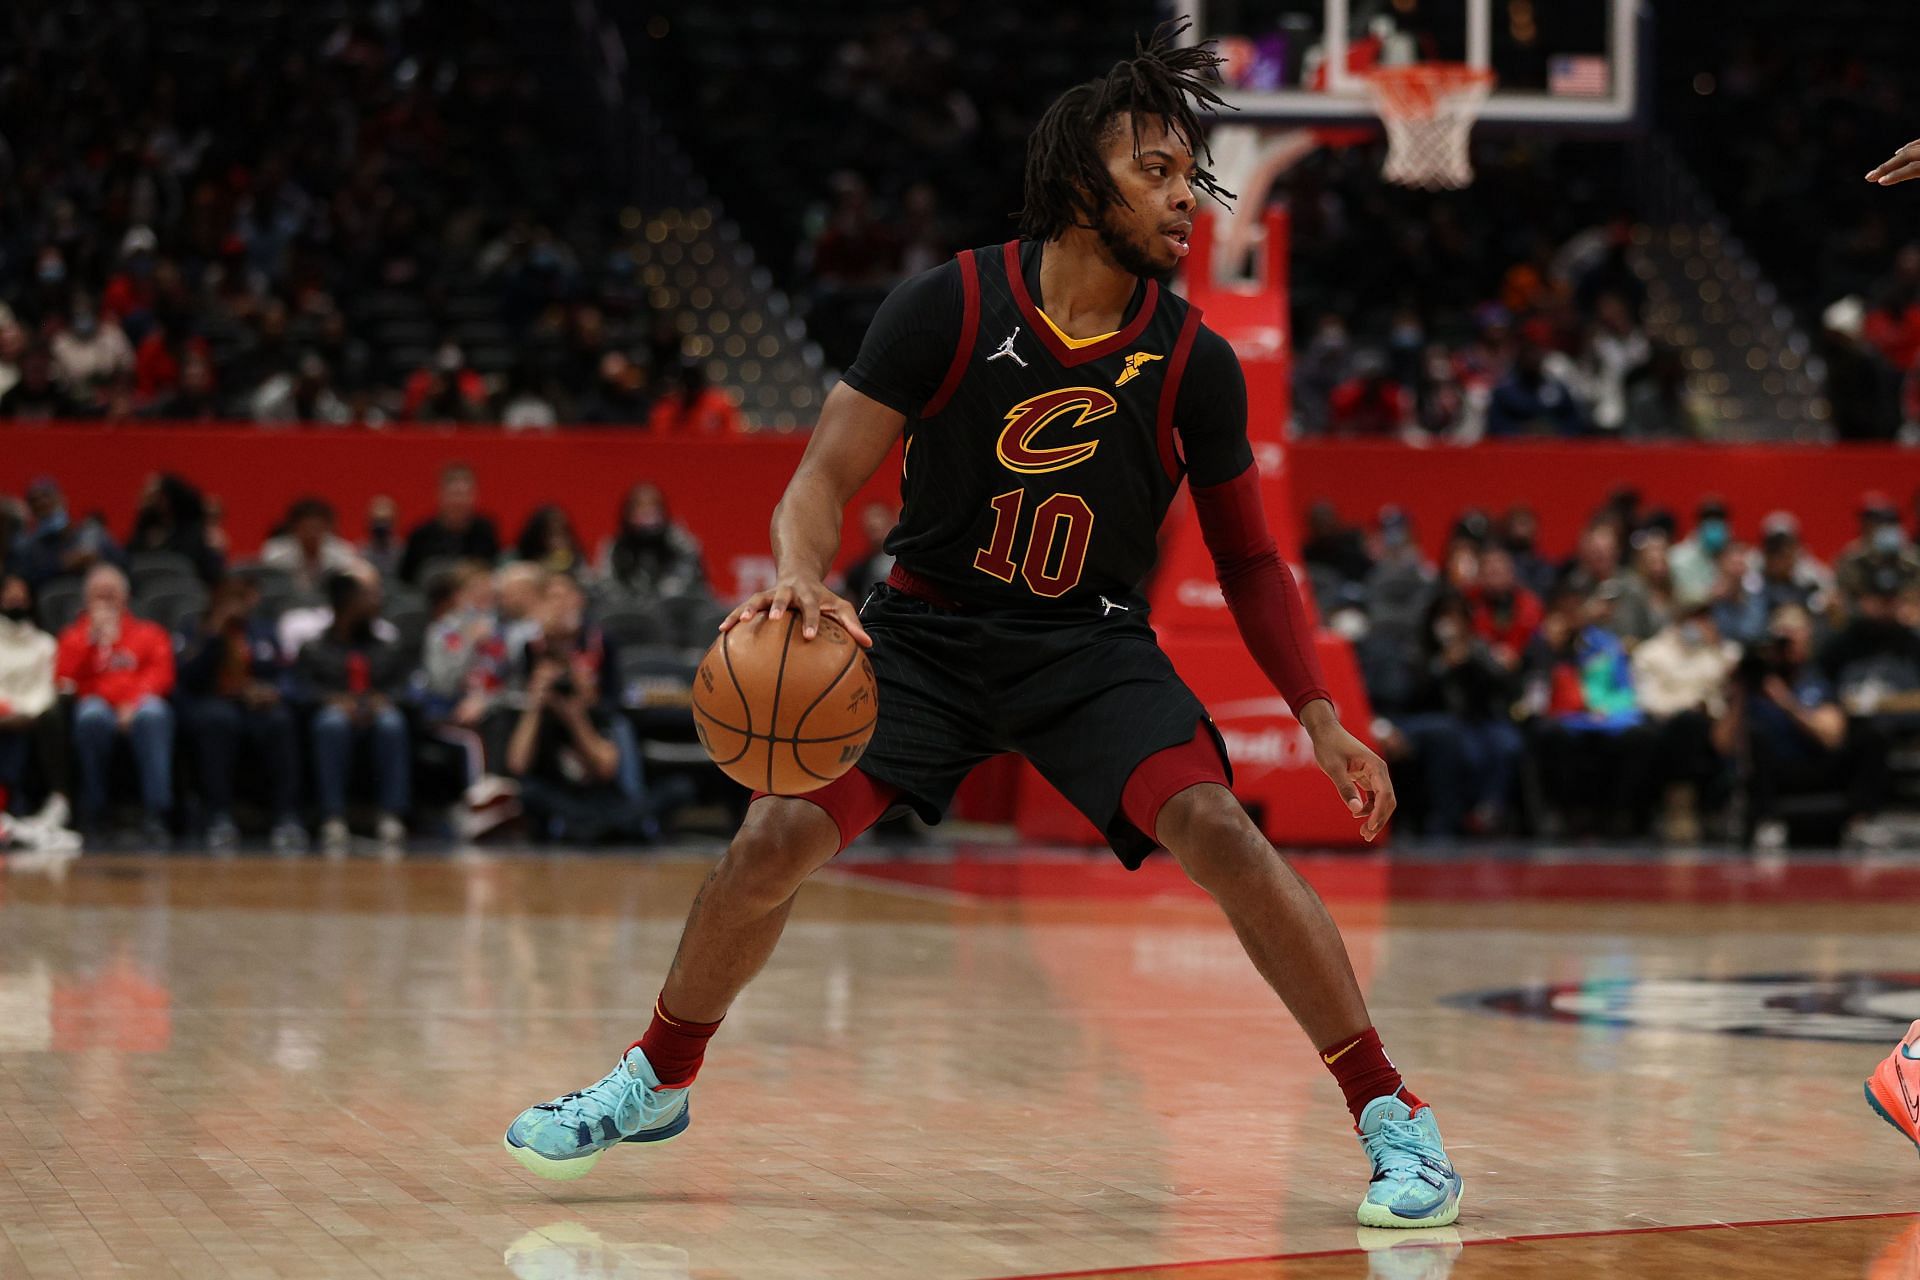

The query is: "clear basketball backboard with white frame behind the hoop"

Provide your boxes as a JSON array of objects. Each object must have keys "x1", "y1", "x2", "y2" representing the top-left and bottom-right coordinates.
[{"x1": 1181, "y1": 0, "x2": 1651, "y2": 129}]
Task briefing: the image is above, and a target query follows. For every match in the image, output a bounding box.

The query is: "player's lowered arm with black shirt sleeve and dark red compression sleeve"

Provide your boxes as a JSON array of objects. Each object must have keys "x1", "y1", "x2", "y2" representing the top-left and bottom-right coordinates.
[{"x1": 1175, "y1": 328, "x2": 1398, "y2": 841}]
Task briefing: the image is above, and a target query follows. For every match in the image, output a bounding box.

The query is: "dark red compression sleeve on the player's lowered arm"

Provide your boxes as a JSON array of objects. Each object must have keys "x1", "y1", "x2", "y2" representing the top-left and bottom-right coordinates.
[{"x1": 1192, "y1": 466, "x2": 1332, "y2": 716}]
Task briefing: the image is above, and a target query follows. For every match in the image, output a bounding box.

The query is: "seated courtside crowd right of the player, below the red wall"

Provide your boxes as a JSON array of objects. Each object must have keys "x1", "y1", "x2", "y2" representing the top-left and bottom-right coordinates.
[{"x1": 1302, "y1": 491, "x2": 1920, "y2": 846}]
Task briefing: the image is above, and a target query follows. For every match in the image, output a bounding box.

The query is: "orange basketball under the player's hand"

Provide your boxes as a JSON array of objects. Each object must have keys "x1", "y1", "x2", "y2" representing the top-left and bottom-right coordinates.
[{"x1": 693, "y1": 612, "x2": 879, "y2": 796}]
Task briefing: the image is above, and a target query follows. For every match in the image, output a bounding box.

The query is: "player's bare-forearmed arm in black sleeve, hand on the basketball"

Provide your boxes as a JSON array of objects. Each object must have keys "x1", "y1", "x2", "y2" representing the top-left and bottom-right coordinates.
[{"x1": 720, "y1": 263, "x2": 964, "y2": 645}]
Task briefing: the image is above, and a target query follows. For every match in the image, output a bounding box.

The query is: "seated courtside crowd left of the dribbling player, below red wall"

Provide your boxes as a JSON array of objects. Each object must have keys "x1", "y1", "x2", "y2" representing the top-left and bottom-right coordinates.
[{"x1": 0, "y1": 464, "x2": 748, "y2": 854}]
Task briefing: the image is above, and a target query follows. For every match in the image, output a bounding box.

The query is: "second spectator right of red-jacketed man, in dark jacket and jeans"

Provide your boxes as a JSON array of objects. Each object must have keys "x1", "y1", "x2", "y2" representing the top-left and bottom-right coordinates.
[{"x1": 296, "y1": 574, "x2": 413, "y2": 858}]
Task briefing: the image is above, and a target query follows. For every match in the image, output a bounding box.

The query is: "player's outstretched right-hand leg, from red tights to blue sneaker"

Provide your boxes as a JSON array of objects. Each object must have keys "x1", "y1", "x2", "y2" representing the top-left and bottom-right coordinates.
[{"x1": 1125, "y1": 759, "x2": 1461, "y2": 1226}]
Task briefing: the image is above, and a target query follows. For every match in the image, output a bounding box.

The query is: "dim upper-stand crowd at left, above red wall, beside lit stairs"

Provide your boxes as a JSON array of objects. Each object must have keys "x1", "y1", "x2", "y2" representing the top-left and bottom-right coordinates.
[{"x1": 0, "y1": 0, "x2": 741, "y2": 432}]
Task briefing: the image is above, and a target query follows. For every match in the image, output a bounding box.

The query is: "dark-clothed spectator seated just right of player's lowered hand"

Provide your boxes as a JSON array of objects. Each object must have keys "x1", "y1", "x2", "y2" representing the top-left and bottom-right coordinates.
[{"x1": 1396, "y1": 593, "x2": 1524, "y2": 837}]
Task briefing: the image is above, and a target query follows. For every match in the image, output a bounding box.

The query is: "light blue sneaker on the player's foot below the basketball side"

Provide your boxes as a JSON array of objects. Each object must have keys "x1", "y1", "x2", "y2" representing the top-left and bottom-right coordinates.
[{"x1": 505, "y1": 1044, "x2": 691, "y2": 1182}]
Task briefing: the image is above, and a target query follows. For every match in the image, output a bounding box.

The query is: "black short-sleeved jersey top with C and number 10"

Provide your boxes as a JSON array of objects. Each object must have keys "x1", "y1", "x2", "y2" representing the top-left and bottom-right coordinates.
[{"x1": 847, "y1": 242, "x2": 1252, "y2": 608}]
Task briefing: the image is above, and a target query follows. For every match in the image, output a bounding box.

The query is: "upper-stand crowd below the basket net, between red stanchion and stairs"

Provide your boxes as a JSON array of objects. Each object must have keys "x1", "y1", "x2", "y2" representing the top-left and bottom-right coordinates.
[{"x1": 1277, "y1": 127, "x2": 1711, "y2": 443}]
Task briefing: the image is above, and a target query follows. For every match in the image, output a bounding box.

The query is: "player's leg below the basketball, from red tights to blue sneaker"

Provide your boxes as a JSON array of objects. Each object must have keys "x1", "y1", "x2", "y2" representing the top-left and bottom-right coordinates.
[{"x1": 505, "y1": 770, "x2": 897, "y2": 1182}]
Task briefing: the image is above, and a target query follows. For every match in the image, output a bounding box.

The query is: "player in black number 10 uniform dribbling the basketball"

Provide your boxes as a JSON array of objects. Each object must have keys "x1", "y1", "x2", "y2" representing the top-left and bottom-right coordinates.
[{"x1": 507, "y1": 29, "x2": 1461, "y2": 1226}]
